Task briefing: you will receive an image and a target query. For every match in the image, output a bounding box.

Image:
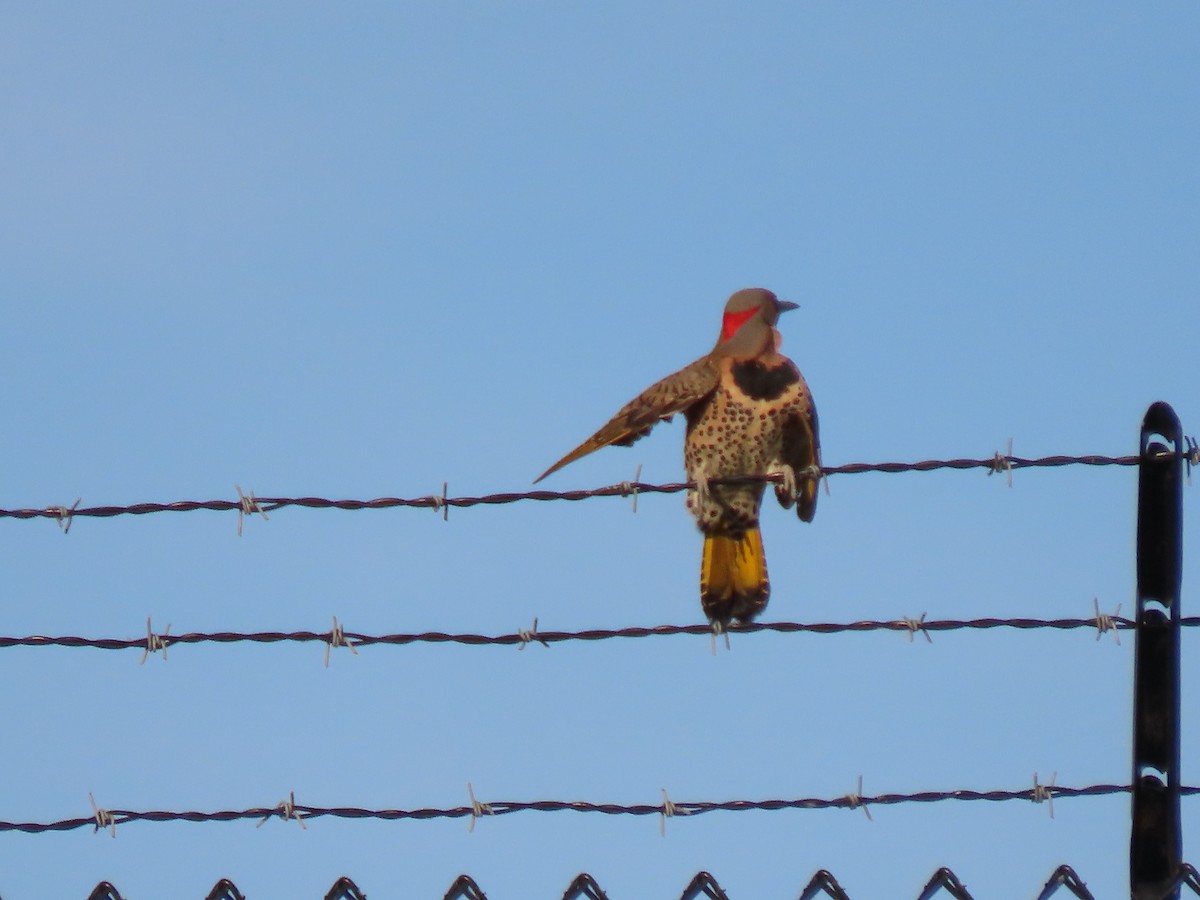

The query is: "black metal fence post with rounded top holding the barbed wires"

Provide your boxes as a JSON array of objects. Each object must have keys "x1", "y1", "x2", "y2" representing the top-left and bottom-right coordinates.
[{"x1": 1129, "y1": 402, "x2": 1184, "y2": 900}]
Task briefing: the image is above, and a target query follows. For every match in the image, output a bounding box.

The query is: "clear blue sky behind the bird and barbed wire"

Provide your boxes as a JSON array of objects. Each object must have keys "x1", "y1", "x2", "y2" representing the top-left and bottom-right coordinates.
[{"x1": 0, "y1": 2, "x2": 1200, "y2": 900}]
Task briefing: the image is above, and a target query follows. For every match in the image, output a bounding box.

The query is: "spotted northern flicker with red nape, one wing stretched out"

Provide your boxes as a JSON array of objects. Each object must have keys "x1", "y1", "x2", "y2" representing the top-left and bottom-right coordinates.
[{"x1": 535, "y1": 288, "x2": 821, "y2": 626}]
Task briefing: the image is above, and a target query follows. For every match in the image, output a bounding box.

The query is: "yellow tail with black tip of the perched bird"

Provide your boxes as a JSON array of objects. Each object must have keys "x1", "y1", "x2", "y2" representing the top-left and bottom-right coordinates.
[{"x1": 700, "y1": 528, "x2": 770, "y2": 625}]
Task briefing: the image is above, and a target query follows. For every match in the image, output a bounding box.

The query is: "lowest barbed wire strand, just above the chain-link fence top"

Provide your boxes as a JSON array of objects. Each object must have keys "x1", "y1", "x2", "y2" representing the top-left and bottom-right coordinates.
[{"x1": 9, "y1": 775, "x2": 1200, "y2": 838}]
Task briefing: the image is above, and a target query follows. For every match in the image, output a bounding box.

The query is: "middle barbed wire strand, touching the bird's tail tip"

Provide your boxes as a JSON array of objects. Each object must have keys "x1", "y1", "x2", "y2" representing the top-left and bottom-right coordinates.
[{"x1": 0, "y1": 613, "x2": 1200, "y2": 665}]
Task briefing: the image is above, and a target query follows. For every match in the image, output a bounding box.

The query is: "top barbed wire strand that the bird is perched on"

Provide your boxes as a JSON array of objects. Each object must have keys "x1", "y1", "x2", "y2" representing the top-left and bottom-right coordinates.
[{"x1": 0, "y1": 451, "x2": 1147, "y2": 533}]
